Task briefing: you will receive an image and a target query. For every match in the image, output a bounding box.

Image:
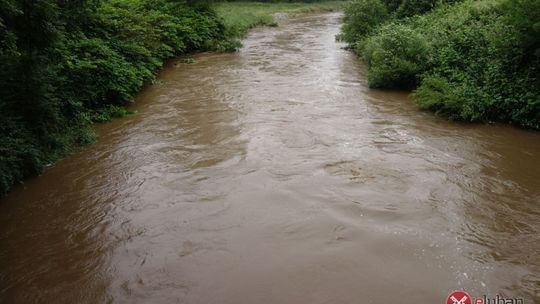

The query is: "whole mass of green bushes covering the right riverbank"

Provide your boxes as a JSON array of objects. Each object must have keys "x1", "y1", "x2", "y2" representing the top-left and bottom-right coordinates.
[{"x1": 340, "y1": 0, "x2": 540, "y2": 129}]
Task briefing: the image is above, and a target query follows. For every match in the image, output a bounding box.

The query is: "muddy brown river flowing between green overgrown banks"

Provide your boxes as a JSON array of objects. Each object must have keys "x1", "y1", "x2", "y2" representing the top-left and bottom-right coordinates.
[{"x1": 0, "y1": 13, "x2": 540, "y2": 304}]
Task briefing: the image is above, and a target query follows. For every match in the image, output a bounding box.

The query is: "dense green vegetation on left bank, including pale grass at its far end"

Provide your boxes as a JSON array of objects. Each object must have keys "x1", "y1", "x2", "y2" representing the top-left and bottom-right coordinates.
[{"x1": 0, "y1": 0, "x2": 338, "y2": 196}]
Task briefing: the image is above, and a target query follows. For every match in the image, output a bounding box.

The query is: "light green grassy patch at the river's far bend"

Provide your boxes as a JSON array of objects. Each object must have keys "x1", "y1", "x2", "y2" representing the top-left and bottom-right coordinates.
[{"x1": 215, "y1": 1, "x2": 344, "y2": 38}]
